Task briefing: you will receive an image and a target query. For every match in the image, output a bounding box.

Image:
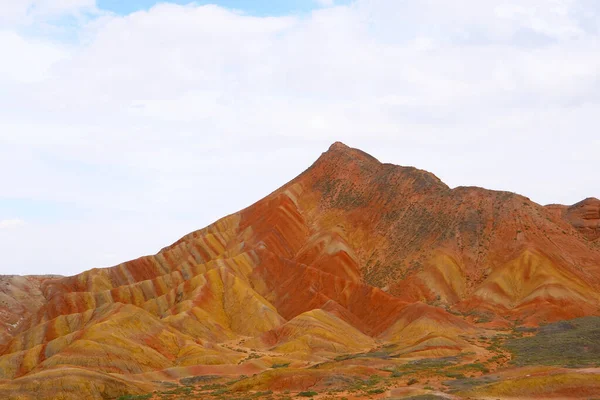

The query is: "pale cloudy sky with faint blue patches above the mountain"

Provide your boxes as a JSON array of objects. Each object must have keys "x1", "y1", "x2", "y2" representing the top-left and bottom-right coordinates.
[{"x1": 0, "y1": 0, "x2": 600, "y2": 275}]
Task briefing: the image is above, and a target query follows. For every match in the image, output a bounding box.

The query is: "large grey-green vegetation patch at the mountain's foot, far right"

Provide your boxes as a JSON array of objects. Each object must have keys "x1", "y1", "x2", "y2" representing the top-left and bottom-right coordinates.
[{"x1": 504, "y1": 317, "x2": 600, "y2": 368}]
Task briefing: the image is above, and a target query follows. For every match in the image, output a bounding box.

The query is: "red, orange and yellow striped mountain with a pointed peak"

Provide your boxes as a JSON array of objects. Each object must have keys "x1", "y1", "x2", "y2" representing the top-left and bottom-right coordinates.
[{"x1": 0, "y1": 143, "x2": 600, "y2": 399}]
